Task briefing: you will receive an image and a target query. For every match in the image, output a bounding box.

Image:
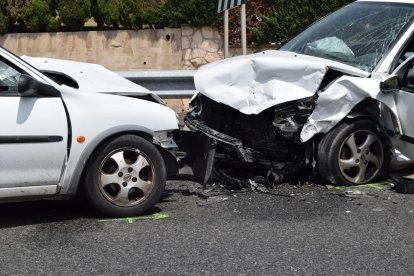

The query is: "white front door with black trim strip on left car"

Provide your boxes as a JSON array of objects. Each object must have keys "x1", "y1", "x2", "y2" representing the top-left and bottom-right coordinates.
[{"x1": 0, "y1": 56, "x2": 68, "y2": 189}]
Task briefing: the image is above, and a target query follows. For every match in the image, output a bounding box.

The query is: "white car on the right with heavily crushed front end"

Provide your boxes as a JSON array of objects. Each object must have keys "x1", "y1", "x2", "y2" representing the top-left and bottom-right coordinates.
[{"x1": 186, "y1": 0, "x2": 414, "y2": 185}]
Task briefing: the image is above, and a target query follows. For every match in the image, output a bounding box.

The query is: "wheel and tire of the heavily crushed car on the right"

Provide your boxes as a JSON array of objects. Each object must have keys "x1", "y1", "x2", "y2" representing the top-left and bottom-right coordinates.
[{"x1": 317, "y1": 119, "x2": 391, "y2": 186}]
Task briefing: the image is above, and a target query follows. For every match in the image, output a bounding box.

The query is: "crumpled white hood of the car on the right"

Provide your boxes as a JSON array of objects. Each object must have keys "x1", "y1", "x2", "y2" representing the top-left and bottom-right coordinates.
[{"x1": 194, "y1": 51, "x2": 368, "y2": 115}]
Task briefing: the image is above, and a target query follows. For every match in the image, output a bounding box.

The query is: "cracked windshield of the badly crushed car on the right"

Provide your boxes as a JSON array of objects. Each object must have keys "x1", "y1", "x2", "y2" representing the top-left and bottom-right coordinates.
[{"x1": 281, "y1": 2, "x2": 414, "y2": 72}]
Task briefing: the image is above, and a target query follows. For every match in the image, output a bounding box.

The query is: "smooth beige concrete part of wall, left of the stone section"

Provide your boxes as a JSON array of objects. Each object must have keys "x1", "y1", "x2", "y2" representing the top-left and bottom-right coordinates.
[{"x1": 0, "y1": 29, "x2": 182, "y2": 70}]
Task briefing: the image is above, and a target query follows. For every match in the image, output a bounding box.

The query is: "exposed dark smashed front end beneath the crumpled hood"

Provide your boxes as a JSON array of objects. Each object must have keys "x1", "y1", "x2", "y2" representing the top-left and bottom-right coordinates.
[{"x1": 185, "y1": 94, "x2": 316, "y2": 182}]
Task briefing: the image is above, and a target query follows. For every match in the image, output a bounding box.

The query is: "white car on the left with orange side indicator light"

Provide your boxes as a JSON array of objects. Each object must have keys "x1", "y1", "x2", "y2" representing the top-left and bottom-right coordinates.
[{"x1": 0, "y1": 48, "x2": 178, "y2": 216}]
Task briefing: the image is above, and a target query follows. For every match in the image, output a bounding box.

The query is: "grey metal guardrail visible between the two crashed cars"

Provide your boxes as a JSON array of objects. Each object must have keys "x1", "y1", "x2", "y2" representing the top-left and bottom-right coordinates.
[{"x1": 117, "y1": 70, "x2": 196, "y2": 97}]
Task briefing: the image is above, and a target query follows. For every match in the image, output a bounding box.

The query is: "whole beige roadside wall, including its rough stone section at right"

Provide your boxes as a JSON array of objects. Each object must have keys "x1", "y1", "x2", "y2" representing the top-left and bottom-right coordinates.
[{"x1": 0, "y1": 27, "x2": 223, "y2": 71}]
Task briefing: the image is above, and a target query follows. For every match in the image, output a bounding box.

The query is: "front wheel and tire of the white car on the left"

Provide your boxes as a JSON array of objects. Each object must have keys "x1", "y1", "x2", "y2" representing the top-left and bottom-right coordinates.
[{"x1": 85, "y1": 135, "x2": 166, "y2": 217}]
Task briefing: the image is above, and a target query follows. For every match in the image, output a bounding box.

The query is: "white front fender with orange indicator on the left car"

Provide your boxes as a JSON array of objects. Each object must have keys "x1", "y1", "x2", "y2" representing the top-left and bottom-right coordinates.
[{"x1": 60, "y1": 86, "x2": 178, "y2": 194}]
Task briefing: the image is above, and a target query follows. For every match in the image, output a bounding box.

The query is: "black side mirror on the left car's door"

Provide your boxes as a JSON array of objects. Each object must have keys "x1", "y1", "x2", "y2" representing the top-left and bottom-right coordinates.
[{"x1": 17, "y1": 74, "x2": 60, "y2": 98}]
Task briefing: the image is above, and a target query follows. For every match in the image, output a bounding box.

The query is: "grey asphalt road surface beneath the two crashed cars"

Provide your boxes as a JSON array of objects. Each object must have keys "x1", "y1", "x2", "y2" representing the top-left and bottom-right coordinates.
[{"x1": 0, "y1": 181, "x2": 414, "y2": 275}]
